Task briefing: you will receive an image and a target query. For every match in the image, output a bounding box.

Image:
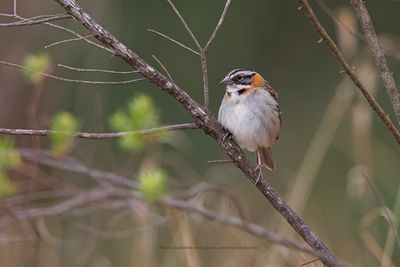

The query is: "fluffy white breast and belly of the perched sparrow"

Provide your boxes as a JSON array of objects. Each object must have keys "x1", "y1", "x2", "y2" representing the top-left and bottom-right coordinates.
[{"x1": 218, "y1": 88, "x2": 280, "y2": 151}]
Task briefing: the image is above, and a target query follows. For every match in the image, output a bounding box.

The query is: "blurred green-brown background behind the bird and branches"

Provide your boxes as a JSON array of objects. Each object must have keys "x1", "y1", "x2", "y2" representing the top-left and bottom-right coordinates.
[{"x1": 0, "y1": 0, "x2": 400, "y2": 267}]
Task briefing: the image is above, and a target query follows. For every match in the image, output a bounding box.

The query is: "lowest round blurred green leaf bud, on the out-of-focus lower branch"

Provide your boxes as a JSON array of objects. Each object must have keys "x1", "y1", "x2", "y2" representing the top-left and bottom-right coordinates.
[{"x1": 139, "y1": 169, "x2": 167, "y2": 203}]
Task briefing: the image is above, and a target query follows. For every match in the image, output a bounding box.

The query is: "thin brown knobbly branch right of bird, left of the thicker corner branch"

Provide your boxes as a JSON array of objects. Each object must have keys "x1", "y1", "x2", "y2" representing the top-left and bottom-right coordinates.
[{"x1": 300, "y1": 0, "x2": 400, "y2": 144}]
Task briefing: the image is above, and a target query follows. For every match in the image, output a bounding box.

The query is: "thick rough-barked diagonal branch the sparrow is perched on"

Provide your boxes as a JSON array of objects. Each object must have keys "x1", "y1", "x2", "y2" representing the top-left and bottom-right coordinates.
[{"x1": 54, "y1": 0, "x2": 342, "y2": 266}]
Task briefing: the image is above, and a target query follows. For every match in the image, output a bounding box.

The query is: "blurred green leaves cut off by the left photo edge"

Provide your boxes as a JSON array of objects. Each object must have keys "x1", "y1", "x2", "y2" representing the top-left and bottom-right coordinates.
[{"x1": 0, "y1": 137, "x2": 21, "y2": 197}]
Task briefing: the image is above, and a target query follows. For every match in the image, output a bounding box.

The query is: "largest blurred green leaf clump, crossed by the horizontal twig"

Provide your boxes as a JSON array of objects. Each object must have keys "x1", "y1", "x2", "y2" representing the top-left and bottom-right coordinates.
[{"x1": 110, "y1": 94, "x2": 162, "y2": 151}]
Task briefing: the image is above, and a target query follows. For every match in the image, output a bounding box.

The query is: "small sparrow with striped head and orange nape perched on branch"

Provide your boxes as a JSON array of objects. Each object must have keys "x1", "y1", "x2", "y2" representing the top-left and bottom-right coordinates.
[{"x1": 218, "y1": 69, "x2": 281, "y2": 184}]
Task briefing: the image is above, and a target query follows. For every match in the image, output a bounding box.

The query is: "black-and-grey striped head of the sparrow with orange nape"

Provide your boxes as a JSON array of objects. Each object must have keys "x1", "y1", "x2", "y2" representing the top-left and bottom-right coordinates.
[{"x1": 220, "y1": 69, "x2": 266, "y2": 93}]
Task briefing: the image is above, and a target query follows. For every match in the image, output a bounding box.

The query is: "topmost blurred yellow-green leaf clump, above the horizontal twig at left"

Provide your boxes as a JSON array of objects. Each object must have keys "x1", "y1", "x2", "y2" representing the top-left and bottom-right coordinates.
[{"x1": 21, "y1": 53, "x2": 51, "y2": 85}]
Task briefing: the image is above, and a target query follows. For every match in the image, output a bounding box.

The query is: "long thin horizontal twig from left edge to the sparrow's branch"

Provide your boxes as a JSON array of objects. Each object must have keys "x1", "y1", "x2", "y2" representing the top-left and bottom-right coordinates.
[{"x1": 0, "y1": 123, "x2": 197, "y2": 139}]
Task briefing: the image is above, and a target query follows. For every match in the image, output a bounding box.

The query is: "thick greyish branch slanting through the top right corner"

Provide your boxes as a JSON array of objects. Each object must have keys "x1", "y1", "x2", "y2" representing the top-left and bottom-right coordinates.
[{"x1": 350, "y1": 0, "x2": 400, "y2": 124}]
